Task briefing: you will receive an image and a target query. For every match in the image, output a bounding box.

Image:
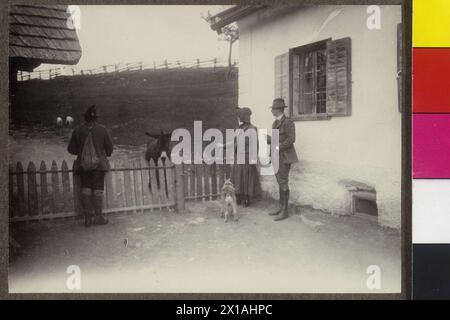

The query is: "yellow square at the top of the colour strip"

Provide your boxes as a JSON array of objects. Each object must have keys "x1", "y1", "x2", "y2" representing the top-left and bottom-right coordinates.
[{"x1": 412, "y1": 0, "x2": 450, "y2": 47}]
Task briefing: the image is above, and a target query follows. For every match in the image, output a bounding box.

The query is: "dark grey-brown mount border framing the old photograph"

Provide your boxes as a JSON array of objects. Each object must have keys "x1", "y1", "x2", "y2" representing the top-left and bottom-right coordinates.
[{"x1": 0, "y1": 0, "x2": 412, "y2": 300}]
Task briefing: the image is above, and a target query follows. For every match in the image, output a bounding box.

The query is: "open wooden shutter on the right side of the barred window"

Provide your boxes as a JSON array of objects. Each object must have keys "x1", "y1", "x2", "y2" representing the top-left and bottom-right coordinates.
[{"x1": 327, "y1": 38, "x2": 352, "y2": 116}]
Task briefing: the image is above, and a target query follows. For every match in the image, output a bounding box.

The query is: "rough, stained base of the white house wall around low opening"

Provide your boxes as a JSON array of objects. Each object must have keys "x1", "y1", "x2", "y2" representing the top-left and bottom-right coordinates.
[{"x1": 261, "y1": 161, "x2": 401, "y2": 229}]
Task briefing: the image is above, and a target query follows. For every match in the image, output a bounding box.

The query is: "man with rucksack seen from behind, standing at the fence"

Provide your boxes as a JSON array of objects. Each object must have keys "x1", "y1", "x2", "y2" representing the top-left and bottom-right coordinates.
[{"x1": 67, "y1": 105, "x2": 113, "y2": 227}]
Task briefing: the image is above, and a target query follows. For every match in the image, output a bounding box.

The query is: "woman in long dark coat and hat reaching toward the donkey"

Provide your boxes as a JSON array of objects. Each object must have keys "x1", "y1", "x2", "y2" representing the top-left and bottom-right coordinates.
[{"x1": 232, "y1": 107, "x2": 258, "y2": 207}]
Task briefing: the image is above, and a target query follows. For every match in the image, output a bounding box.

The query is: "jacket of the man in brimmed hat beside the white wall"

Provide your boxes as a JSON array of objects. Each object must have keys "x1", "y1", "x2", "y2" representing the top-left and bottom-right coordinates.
[{"x1": 272, "y1": 116, "x2": 298, "y2": 164}]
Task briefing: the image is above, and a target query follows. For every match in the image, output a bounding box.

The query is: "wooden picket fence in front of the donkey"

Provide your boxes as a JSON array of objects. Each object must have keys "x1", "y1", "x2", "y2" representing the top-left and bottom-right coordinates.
[{"x1": 9, "y1": 159, "x2": 232, "y2": 222}]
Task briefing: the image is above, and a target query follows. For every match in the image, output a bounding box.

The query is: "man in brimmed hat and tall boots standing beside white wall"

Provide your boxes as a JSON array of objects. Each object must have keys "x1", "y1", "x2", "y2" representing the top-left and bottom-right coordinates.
[{"x1": 267, "y1": 98, "x2": 298, "y2": 221}]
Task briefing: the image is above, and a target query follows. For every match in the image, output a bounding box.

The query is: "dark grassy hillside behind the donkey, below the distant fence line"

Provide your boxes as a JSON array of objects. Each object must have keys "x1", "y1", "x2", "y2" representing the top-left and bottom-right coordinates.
[{"x1": 11, "y1": 68, "x2": 238, "y2": 145}]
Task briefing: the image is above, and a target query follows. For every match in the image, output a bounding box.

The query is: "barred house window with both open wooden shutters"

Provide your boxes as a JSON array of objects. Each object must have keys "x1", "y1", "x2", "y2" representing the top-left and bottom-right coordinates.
[{"x1": 275, "y1": 38, "x2": 351, "y2": 120}]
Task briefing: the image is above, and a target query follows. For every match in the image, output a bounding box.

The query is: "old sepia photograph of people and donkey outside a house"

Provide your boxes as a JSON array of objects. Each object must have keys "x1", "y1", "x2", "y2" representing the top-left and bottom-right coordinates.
[{"x1": 8, "y1": 2, "x2": 404, "y2": 294}]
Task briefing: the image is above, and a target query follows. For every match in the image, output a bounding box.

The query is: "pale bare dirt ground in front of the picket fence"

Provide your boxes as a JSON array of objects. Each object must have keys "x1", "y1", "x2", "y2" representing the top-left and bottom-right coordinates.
[{"x1": 9, "y1": 201, "x2": 401, "y2": 293}]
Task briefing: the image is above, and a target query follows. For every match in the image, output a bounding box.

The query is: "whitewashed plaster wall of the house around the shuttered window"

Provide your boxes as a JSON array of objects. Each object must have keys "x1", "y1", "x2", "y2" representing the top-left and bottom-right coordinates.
[{"x1": 239, "y1": 6, "x2": 401, "y2": 228}]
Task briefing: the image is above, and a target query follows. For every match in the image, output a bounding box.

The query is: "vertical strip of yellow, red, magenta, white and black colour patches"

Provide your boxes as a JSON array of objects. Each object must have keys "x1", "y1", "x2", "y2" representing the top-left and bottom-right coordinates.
[{"x1": 412, "y1": 0, "x2": 450, "y2": 299}]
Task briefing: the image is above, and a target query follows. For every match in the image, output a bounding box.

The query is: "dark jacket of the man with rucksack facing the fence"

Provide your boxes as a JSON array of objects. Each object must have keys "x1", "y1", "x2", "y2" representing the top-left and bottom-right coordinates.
[{"x1": 67, "y1": 123, "x2": 114, "y2": 171}]
